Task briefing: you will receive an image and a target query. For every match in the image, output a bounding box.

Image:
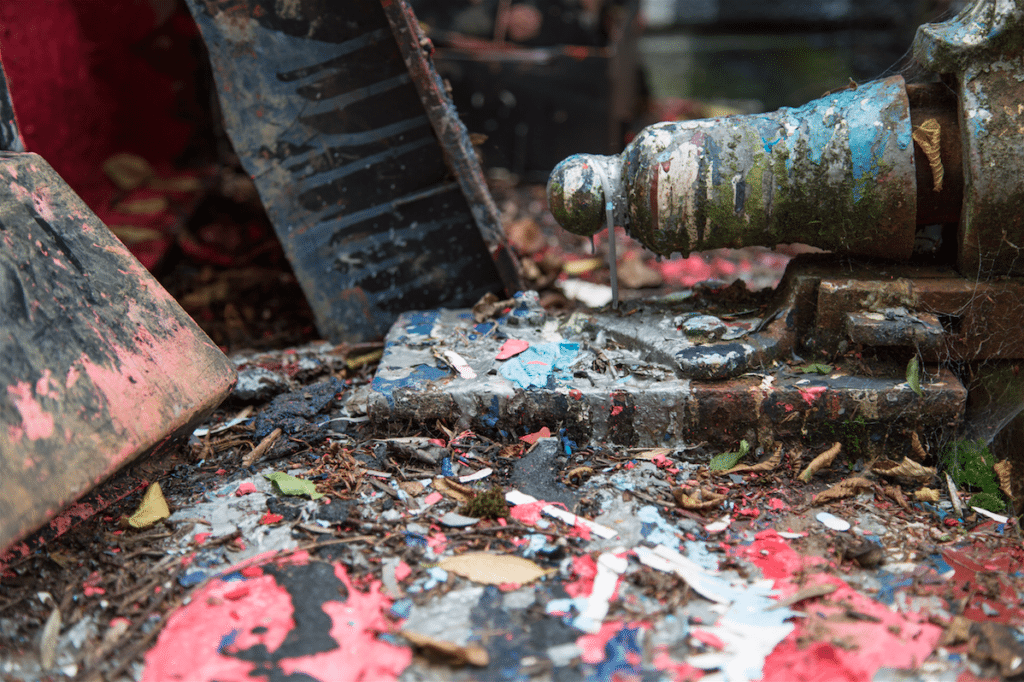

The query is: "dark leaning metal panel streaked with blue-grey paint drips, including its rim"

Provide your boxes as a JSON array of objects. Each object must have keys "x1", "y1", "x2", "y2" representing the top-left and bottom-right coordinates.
[{"x1": 189, "y1": 0, "x2": 516, "y2": 341}]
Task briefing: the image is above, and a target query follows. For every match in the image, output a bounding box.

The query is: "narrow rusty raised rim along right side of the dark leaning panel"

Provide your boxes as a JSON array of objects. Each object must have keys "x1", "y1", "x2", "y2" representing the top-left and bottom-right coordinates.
[{"x1": 381, "y1": 0, "x2": 523, "y2": 295}]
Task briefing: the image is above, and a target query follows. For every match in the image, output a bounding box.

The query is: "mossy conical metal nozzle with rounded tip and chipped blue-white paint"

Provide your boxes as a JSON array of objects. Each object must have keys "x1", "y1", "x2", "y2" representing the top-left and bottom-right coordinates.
[{"x1": 549, "y1": 76, "x2": 916, "y2": 258}]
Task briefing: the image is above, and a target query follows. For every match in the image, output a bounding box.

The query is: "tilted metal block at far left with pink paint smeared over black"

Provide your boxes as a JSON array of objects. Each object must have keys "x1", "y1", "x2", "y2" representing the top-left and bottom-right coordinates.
[{"x1": 0, "y1": 153, "x2": 237, "y2": 549}]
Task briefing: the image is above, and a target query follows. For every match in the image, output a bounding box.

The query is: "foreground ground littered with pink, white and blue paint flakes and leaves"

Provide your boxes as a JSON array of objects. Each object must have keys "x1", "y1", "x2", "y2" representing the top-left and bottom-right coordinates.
[{"x1": 0, "y1": 337, "x2": 1024, "y2": 682}]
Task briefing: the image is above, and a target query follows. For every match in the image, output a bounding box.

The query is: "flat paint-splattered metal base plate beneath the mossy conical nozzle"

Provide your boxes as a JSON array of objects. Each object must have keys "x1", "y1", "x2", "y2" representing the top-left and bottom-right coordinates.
[{"x1": 369, "y1": 286, "x2": 966, "y2": 454}]
